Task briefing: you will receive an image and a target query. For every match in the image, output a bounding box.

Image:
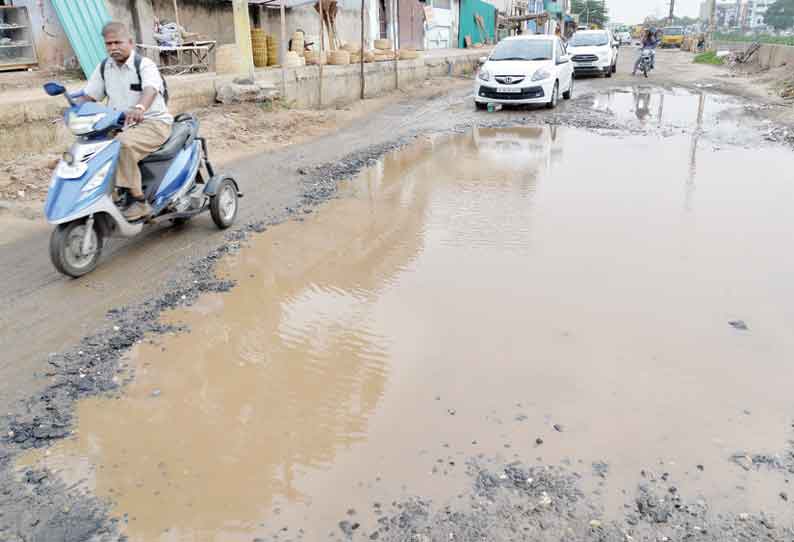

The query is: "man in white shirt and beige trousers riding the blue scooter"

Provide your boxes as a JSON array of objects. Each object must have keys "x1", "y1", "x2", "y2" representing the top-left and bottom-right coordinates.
[{"x1": 78, "y1": 22, "x2": 174, "y2": 221}]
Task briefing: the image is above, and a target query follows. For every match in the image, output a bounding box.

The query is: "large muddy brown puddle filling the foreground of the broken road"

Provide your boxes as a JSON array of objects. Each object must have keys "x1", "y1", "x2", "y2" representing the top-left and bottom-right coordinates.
[{"x1": 21, "y1": 127, "x2": 794, "y2": 542}]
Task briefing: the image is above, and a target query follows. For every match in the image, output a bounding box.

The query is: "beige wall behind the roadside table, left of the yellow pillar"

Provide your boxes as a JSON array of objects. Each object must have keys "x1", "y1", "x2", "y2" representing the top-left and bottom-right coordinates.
[{"x1": 152, "y1": 0, "x2": 234, "y2": 44}]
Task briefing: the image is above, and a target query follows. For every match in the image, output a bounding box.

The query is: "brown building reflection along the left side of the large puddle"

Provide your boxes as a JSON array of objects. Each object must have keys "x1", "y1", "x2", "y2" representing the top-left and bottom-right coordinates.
[{"x1": 23, "y1": 128, "x2": 560, "y2": 541}]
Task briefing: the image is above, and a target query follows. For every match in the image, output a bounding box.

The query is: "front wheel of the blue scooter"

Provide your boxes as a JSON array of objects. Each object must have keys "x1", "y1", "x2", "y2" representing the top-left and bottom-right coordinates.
[{"x1": 50, "y1": 221, "x2": 103, "y2": 278}]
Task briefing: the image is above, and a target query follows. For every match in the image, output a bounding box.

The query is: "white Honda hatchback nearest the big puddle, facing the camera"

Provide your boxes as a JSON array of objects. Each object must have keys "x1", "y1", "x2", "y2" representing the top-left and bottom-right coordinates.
[{"x1": 474, "y1": 35, "x2": 573, "y2": 109}]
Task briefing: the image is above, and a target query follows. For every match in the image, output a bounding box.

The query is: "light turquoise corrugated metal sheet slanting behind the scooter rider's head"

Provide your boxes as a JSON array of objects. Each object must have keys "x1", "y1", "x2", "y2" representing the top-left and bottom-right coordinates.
[{"x1": 52, "y1": 0, "x2": 110, "y2": 77}]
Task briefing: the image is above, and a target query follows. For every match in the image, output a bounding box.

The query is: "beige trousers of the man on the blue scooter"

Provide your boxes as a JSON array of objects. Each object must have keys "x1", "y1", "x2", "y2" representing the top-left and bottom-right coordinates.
[{"x1": 116, "y1": 120, "x2": 171, "y2": 194}]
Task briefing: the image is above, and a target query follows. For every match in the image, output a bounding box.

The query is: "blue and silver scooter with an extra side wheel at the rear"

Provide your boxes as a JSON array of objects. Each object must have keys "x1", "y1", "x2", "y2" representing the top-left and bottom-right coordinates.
[{"x1": 44, "y1": 82, "x2": 242, "y2": 277}]
